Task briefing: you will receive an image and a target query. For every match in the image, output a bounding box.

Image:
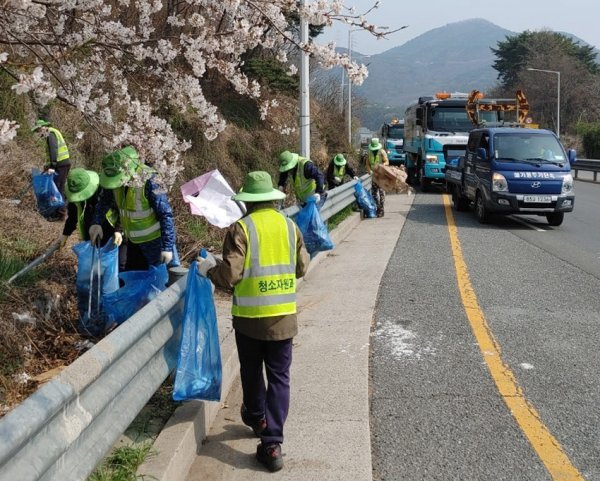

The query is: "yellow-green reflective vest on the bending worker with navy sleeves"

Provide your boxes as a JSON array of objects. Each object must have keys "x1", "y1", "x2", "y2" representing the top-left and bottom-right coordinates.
[{"x1": 113, "y1": 177, "x2": 161, "y2": 244}]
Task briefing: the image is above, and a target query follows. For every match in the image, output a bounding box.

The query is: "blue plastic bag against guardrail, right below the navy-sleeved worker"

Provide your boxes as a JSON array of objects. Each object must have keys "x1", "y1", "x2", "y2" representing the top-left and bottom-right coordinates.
[{"x1": 102, "y1": 264, "x2": 169, "y2": 328}]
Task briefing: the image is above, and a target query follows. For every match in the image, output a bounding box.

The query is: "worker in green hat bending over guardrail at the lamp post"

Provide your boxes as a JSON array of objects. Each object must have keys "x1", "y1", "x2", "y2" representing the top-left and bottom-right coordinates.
[{"x1": 277, "y1": 150, "x2": 326, "y2": 205}]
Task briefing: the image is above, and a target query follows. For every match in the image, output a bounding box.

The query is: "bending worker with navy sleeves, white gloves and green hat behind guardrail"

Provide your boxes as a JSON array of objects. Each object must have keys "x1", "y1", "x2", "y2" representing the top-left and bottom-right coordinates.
[{"x1": 89, "y1": 146, "x2": 179, "y2": 271}]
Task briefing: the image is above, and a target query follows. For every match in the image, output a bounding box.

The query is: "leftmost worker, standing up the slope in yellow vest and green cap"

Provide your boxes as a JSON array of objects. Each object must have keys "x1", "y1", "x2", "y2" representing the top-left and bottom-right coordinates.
[{"x1": 31, "y1": 119, "x2": 71, "y2": 220}]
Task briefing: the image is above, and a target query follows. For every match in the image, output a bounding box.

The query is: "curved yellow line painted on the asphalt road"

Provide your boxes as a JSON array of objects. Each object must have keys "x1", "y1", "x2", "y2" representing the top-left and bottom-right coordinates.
[{"x1": 443, "y1": 194, "x2": 584, "y2": 480}]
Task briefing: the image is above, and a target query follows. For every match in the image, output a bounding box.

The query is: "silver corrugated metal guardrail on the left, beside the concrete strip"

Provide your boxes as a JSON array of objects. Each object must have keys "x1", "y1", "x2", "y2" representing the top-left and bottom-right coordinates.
[{"x1": 0, "y1": 175, "x2": 371, "y2": 481}]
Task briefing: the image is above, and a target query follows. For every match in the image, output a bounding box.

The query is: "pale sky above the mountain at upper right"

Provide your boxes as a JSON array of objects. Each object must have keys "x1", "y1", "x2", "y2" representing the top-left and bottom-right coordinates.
[{"x1": 324, "y1": 0, "x2": 600, "y2": 54}]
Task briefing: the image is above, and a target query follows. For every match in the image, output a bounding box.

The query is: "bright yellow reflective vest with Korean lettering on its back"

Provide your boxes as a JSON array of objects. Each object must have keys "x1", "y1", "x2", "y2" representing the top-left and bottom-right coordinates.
[{"x1": 231, "y1": 208, "x2": 296, "y2": 318}]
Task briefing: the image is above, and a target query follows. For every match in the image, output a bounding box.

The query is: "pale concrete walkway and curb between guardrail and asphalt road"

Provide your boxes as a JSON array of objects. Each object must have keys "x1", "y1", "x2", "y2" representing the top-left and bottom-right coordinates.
[{"x1": 138, "y1": 195, "x2": 414, "y2": 481}]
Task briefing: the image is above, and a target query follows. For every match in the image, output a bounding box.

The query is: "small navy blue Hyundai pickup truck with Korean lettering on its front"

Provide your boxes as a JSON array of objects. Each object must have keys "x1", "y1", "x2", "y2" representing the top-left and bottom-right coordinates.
[{"x1": 445, "y1": 127, "x2": 576, "y2": 226}]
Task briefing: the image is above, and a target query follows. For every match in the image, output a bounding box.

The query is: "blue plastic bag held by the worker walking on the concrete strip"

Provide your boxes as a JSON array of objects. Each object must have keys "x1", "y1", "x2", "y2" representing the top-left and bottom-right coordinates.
[{"x1": 173, "y1": 262, "x2": 222, "y2": 401}]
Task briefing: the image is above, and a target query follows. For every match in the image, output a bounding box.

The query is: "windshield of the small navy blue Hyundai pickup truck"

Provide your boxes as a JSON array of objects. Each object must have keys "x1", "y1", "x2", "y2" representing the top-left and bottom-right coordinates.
[{"x1": 493, "y1": 133, "x2": 565, "y2": 164}]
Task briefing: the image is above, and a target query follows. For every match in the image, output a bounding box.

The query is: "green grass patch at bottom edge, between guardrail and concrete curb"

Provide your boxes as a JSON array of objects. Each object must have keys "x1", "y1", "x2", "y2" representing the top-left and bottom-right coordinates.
[{"x1": 88, "y1": 441, "x2": 152, "y2": 481}]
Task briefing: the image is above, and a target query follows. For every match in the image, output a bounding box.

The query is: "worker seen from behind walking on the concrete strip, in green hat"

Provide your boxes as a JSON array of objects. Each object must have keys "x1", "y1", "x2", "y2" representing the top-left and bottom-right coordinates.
[{"x1": 198, "y1": 171, "x2": 310, "y2": 471}]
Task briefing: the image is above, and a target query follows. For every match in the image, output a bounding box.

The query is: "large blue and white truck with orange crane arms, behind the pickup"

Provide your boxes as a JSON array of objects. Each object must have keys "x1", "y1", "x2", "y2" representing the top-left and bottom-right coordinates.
[{"x1": 404, "y1": 90, "x2": 529, "y2": 192}]
